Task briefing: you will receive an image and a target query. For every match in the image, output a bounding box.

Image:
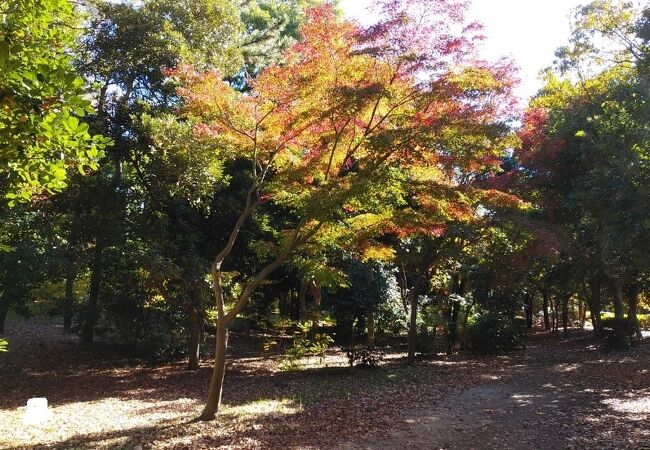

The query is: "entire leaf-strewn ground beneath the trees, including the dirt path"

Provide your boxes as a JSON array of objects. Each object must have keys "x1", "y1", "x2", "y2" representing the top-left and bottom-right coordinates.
[{"x1": 0, "y1": 320, "x2": 650, "y2": 450}]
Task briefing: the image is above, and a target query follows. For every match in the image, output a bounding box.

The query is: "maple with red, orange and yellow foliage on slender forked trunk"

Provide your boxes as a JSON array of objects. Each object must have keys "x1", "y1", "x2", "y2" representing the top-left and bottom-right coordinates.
[{"x1": 168, "y1": 1, "x2": 513, "y2": 420}]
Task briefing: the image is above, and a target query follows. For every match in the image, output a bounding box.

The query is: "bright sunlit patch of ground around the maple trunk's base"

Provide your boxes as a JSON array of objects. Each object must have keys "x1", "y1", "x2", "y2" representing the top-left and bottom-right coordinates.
[{"x1": 0, "y1": 393, "x2": 303, "y2": 448}]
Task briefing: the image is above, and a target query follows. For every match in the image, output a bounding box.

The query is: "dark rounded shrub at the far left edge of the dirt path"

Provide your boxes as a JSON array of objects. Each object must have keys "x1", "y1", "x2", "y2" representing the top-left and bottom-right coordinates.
[{"x1": 467, "y1": 314, "x2": 523, "y2": 353}]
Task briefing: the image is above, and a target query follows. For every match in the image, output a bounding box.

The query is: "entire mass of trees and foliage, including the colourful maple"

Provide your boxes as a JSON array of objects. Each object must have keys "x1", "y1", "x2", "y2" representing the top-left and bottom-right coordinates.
[{"x1": 0, "y1": 0, "x2": 650, "y2": 430}]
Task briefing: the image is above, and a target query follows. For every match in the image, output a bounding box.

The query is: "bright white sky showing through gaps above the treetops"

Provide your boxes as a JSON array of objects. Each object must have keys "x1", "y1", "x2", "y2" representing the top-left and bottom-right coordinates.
[{"x1": 339, "y1": 0, "x2": 587, "y2": 99}]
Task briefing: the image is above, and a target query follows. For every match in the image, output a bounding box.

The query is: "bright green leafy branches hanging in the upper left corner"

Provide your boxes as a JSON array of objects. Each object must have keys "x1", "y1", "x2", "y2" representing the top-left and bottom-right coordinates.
[{"x1": 0, "y1": 0, "x2": 109, "y2": 205}]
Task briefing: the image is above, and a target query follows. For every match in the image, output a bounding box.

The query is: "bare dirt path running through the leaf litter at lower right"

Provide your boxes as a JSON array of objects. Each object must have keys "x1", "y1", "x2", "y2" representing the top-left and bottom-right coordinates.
[{"x1": 344, "y1": 335, "x2": 650, "y2": 450}]
